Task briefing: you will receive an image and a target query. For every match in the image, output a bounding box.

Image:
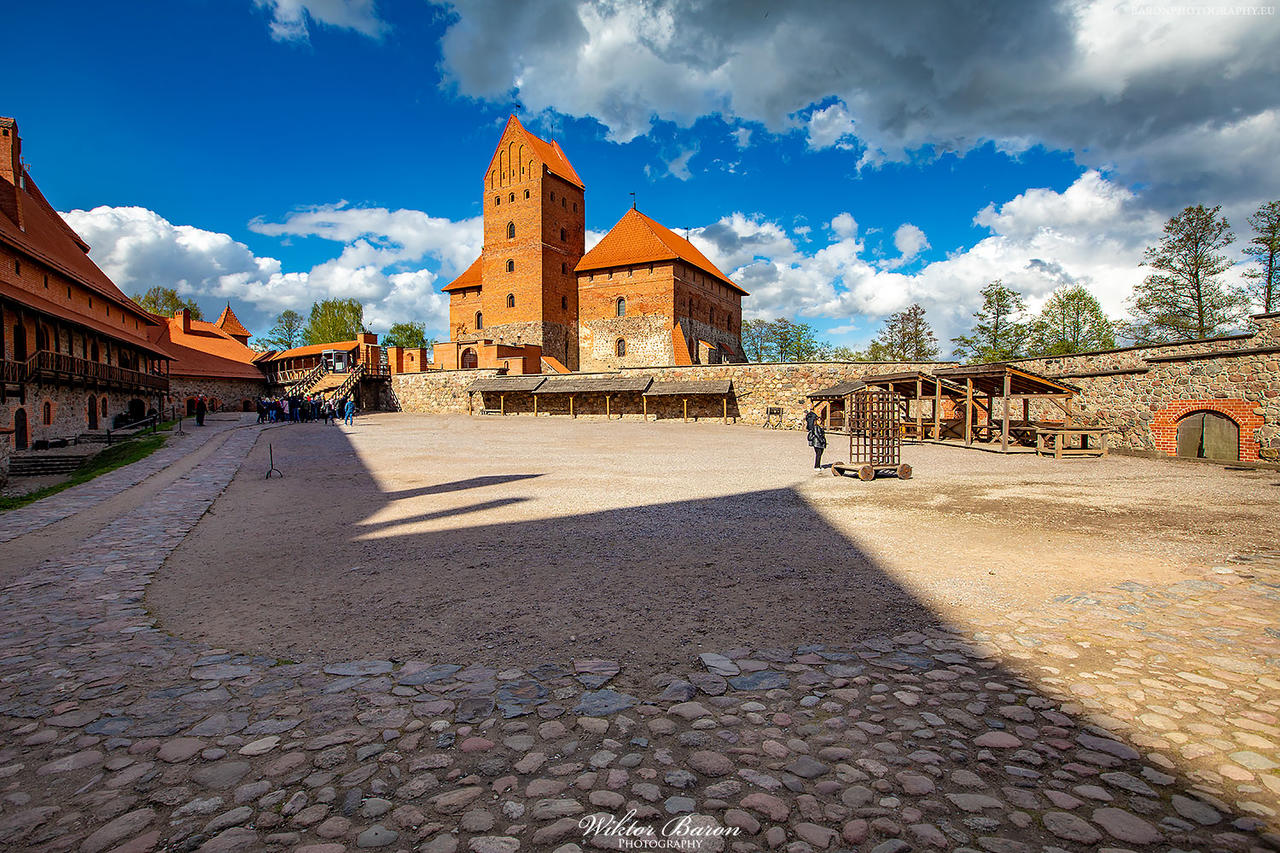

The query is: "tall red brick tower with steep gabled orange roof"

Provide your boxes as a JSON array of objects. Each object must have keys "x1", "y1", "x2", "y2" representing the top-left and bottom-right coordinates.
[{"x1": 476, "y1": 115, "x2": 586, "y2": 369}]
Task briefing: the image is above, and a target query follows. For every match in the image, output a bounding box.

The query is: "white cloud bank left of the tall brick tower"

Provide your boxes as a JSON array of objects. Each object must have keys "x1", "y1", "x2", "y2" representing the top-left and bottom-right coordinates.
[{"x1": 63, "y1": 204, "x2": 483, "y2": 334}]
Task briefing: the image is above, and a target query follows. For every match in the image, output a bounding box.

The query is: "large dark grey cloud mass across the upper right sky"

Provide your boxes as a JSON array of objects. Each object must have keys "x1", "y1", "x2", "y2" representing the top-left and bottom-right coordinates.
[{"x1": 435, "y1": 0, "x2": 1280, "y2": 207}]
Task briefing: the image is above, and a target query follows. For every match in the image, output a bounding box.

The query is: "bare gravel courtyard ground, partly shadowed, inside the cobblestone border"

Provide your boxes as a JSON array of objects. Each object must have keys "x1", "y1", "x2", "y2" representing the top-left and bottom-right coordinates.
[{"x1": 147, "y1": 414, "x2": 1280, "y2": 674}]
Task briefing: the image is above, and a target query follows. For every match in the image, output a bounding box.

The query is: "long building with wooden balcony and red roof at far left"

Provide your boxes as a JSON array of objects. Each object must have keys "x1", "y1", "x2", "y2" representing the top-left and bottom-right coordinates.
[{"x1": 0, "y1": 118, "x2": 170, "y2": 450}]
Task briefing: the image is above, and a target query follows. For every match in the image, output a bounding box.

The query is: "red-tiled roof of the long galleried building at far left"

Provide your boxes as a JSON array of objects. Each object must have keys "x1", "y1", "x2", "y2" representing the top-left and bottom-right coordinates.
[{"x1": 0, "y1": 118, "x2": 156, "y2": 345}]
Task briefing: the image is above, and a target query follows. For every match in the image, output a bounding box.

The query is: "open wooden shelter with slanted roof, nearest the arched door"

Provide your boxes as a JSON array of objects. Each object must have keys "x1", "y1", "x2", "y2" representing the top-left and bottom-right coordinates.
[{"x1": 934, "y1": 361, "x2": 1078, "y2": 452}]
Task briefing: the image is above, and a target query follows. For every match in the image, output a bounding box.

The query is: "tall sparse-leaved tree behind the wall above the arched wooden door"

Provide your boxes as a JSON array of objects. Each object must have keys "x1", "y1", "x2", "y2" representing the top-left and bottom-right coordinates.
[{"x1": 1125, "y1": 205, "x2": 1248, "y2": 343}]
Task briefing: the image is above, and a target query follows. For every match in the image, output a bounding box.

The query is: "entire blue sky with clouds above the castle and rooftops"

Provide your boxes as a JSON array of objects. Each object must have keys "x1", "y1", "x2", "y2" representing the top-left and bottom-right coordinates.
[{"x1": 0, "y1": 0, "x2": 1280, "y2": 350}]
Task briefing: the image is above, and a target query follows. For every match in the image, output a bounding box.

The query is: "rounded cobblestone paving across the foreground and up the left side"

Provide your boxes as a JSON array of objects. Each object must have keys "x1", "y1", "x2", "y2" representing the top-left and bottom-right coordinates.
[{"x1": 0, "y1": 429, "x2": 1280, "y2": 853}]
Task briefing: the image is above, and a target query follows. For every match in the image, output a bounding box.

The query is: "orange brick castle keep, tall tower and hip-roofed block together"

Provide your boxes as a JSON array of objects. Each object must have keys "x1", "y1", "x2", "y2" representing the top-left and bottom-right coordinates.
[{"x1": 434, "y1": 115, "x2": 746, "y2": 374}]
